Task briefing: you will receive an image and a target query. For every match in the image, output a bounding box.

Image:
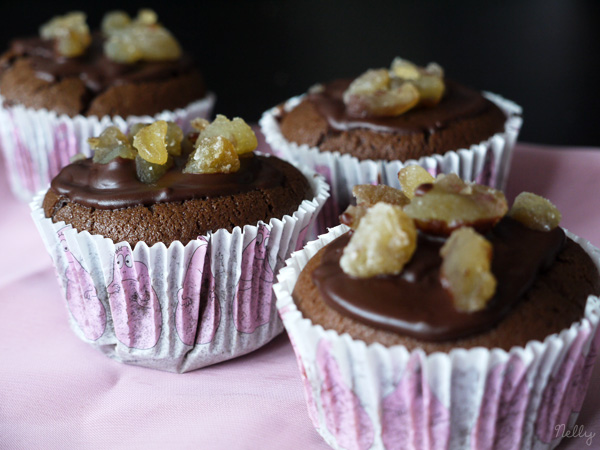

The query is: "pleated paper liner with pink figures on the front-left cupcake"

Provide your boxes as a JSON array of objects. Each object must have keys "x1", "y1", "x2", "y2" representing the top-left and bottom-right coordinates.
[{"x1": 31, "y1": 162, "x2": 328, "y2": 372}]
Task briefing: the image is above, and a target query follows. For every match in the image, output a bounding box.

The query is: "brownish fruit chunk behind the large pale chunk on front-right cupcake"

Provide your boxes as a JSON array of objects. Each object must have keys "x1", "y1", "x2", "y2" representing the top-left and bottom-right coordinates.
[{"x1": 340, "y1": 184, "x2": 409, "y2": 229}]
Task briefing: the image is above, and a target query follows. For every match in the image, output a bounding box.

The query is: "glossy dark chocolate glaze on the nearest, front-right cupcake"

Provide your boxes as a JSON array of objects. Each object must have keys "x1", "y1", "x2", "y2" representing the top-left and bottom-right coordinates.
[{"x1": 312, "y1": 218, "x2": 566, "y2": 341}]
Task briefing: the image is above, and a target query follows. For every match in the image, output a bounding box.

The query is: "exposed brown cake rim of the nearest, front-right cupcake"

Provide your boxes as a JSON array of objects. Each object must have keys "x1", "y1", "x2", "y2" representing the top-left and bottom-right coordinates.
[{"x1": 293, "y1": 239, "x2": 600, "y2": 353}]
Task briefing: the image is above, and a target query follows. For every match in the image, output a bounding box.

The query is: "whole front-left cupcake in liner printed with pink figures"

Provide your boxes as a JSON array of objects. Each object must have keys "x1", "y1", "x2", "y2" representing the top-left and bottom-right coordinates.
[{"x1": 31, "y1": 115, "x2": 327, "y2": 372}]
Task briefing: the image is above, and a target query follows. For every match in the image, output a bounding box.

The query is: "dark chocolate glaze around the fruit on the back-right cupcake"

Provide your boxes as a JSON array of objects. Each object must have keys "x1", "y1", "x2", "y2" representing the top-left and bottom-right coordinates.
[{"x1": 307, "y1": 80, "x2": 494, "y2": 134}]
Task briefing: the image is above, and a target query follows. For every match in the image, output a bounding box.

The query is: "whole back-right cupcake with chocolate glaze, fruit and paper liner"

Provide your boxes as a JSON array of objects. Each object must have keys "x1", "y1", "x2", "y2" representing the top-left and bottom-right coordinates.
[{"x1": 261, "y1": 58, "x2": 522, "y2": 237}]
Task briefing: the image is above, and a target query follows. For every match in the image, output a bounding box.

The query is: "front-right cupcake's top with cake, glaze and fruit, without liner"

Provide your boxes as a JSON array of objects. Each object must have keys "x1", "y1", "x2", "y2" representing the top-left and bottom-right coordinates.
[{"x1": 294, "y1": 166, "x2": 600, "y2": 351}]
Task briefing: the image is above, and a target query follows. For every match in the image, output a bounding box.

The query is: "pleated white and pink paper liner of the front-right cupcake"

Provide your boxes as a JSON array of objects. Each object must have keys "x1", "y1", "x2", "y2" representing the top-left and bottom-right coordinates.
[{"x1": 274, "y1": 226, "x2": 600, "y2": 450}]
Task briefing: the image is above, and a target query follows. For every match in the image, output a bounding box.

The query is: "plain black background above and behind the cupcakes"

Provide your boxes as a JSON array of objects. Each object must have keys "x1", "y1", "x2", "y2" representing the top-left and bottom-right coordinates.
[{"x1": 0, "y1": 0, "x2": 600, "y2": 146}]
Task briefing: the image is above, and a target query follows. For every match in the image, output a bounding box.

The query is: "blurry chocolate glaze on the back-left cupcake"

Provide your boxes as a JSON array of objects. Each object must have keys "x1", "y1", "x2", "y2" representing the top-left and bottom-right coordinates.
[{"x1": 10, "y1": 33, "x2": 193, "y2": 92}]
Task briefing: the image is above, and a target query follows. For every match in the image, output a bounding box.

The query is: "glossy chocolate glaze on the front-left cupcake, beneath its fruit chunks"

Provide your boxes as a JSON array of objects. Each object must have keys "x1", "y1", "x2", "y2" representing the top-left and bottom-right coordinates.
[{"x1": 51, "y1": 155, "x2": 285, "y2": 209}]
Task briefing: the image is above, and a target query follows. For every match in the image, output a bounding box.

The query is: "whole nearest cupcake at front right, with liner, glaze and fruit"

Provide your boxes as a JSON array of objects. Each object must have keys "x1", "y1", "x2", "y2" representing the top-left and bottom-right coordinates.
[{"x1": 274, "y1": 166, "x2": 600, "y2": 449}]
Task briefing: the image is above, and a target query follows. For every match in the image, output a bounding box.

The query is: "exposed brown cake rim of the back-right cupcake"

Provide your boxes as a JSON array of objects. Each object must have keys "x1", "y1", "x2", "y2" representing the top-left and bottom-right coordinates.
[{"x1": 280, "y1": 92, "x2": 506, "y2": 161}]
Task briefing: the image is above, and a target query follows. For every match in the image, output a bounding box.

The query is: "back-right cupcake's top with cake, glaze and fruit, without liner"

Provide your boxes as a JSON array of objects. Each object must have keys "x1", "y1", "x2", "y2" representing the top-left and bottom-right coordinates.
[{"x1": 280, "y1": 58, "x2": 506, "y2": 161}]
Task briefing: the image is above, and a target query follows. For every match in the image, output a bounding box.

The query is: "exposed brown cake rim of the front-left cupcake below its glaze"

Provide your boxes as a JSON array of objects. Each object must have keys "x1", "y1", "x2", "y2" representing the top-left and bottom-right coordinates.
[{"x1": 43, "y1": 158, "x2": 313, "y2": 247}]
